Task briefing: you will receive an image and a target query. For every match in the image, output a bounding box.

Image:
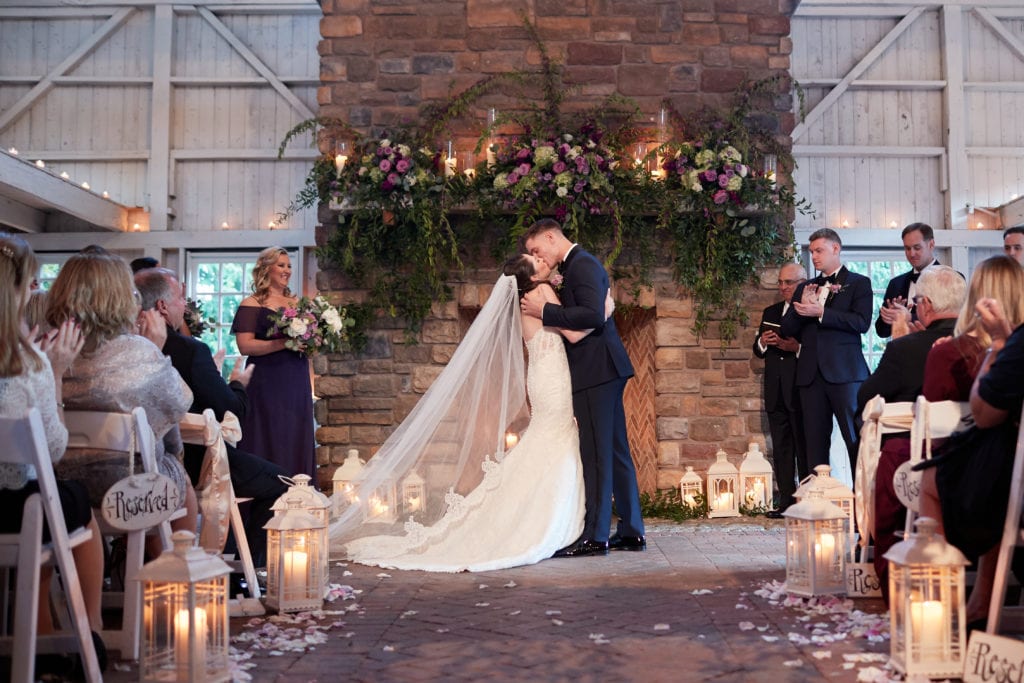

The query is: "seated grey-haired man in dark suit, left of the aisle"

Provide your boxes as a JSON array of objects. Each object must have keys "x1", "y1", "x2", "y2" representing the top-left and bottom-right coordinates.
[{"x1": 135, "y1": 268, "x2": 288, "y2": 567}]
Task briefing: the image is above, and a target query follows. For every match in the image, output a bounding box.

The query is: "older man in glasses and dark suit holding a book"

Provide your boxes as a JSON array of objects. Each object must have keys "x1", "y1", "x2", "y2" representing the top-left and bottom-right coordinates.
[{"x1": 754, "y1": 263, "x2": 808, "y2": 511}]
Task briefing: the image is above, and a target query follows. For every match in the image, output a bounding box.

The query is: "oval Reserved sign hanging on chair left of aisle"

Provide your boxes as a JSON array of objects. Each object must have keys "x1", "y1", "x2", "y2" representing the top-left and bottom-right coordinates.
[{"x1": 100, "y1": 473, "x2": 181, "y2": 531}]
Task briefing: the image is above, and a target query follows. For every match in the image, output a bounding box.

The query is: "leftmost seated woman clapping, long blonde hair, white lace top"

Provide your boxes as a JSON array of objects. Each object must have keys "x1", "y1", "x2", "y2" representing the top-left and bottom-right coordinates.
[{"x1": 0, "y1": 233, "x2": 105, "y2": 664}]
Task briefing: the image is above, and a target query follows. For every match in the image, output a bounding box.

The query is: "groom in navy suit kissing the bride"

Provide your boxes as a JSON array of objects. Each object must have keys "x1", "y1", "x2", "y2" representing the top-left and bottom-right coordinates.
[{"x1": 521, "y1": 218, "x2": 647, "y2": 557}]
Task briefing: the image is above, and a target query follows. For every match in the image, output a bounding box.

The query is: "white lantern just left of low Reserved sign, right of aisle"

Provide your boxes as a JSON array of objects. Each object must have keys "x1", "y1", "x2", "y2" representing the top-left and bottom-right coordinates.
[{"x1": 782, "y1": 490, "x2": 847, "y2": 596}]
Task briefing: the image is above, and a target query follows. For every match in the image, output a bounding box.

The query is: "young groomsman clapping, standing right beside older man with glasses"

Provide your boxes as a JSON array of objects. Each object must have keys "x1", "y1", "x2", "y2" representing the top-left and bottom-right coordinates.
[{"x1": 780, "y1": 227, "x2": 872, "y2": 471}]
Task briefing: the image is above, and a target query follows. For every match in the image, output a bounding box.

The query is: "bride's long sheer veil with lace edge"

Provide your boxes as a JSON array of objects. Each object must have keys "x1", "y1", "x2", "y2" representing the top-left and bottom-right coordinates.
[{"x1": 330, "y1": 275, "x2": 528, "y2": 551}]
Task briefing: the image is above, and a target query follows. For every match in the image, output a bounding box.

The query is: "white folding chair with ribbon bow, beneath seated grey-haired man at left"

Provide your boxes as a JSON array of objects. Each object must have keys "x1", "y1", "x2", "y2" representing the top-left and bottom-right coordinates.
[{"x1": 178, "y1": 409, "x2": 262, "y2": 615}]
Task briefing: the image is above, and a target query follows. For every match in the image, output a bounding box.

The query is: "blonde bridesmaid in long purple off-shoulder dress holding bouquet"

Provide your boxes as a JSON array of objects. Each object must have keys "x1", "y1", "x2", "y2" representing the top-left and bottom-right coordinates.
[{"x1": 231, "y1": 247, "x2": 316, "y2": 480}]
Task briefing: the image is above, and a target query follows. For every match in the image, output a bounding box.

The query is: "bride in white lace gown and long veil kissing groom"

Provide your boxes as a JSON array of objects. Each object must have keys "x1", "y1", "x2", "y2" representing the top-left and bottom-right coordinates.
[{"x1": 330, "y1": 254, "x2": 613, "y2": 572}]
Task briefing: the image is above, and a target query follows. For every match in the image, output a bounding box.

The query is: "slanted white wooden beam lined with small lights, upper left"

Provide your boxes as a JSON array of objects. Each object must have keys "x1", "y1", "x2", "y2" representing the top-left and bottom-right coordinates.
[{"x1": 0, "y1": 154, "x2": 128, "y2": 230}]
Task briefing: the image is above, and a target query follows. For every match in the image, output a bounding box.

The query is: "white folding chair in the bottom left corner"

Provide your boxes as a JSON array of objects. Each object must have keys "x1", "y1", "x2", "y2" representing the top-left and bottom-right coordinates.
[{"x1": 0, "y1": 408, "x2": 102, "y2": 683}]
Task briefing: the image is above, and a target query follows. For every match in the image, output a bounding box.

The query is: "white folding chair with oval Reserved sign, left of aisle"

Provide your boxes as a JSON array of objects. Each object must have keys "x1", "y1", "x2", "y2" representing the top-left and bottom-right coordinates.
[{"x1": 65, "y1": 408, "x2": 185, "y2": 659}]
